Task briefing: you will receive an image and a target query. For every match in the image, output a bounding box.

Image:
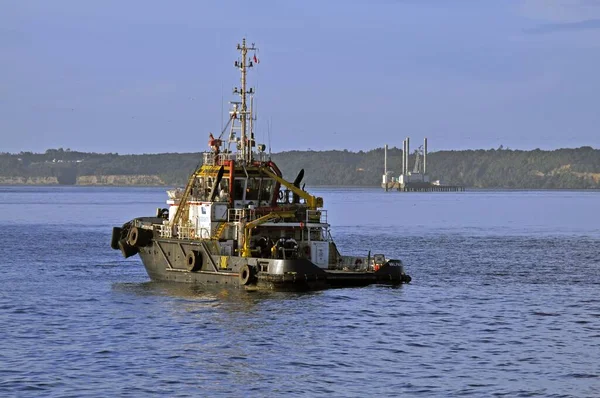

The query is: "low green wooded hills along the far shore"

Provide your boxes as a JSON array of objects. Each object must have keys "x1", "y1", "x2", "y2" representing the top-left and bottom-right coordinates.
[{"x1": 0, "y1": 147, "x2": 600, "y2": 189}]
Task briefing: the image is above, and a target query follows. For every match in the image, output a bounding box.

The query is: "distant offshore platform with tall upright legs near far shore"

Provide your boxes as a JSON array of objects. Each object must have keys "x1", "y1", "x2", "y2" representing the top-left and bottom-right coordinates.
[{"x1": 381, "y1": 137, "x2": 465, "y2": 192}]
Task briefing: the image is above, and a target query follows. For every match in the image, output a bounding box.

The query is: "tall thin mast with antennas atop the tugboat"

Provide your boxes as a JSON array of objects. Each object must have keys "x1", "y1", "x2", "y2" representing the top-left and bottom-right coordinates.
[{"x1": 233, "y1": 38, "x2": 256, "y2": 163}]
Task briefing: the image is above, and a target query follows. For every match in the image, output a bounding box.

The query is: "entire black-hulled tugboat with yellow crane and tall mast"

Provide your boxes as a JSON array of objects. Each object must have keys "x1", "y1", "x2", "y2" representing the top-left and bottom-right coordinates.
[{"x1": 111, "y1": 39, "x2": 411, "y2": 291}]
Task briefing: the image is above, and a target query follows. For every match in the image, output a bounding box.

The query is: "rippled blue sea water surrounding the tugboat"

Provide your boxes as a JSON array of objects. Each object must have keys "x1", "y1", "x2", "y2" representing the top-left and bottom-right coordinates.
[{"x1": 0, "y1": 187, "x2": 600, "y2": 397}]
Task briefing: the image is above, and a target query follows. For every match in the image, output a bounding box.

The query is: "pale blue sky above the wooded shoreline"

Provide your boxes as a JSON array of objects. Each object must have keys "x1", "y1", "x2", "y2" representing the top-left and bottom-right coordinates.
[{"x1": 0, "y1": 0, "x2": 600, "y2": 153}]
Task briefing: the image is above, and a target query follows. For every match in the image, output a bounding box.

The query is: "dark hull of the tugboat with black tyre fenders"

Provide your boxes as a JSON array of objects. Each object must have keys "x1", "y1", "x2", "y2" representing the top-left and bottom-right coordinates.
[{"x1": 138, "y1": 239, "x2": 410, "y2": 291}]
